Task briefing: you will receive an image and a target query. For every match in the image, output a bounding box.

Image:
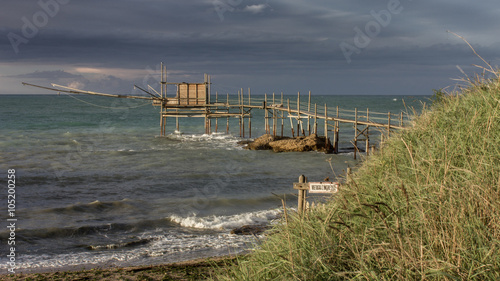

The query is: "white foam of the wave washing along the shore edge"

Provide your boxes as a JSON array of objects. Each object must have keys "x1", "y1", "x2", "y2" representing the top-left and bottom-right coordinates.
[{"x1": 0, "y1": 229, "x2": 257, "y2": 272}]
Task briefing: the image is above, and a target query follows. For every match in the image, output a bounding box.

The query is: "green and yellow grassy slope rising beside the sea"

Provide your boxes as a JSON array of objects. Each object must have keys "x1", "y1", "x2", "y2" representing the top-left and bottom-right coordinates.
[{"x1": 218, "y1": 73, "x2": 500, "y2": 280}]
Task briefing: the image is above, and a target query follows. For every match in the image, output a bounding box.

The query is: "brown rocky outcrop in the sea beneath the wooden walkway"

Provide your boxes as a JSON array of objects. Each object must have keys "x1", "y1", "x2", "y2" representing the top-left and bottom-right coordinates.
[{"x1": 241, "y1": 134, "x2": 333, "y2": 153}]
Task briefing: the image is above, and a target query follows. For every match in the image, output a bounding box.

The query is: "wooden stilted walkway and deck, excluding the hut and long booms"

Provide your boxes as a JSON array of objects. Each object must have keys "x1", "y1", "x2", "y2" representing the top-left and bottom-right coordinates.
[{"x1": 158, "y1": 89, "x2": 409, "y2": 159}]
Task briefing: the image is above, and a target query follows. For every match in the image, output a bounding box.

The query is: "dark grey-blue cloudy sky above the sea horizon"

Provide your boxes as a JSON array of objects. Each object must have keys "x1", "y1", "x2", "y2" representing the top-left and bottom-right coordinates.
[{"x1": 0, "y1": 0, "x2": 500, "y2": 95}]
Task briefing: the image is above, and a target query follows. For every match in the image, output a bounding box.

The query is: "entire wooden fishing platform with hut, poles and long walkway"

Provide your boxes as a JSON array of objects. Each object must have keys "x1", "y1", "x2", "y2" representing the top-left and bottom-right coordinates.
[{"x1": 23, "y1": 65, "x2": 409, "y2": 159}]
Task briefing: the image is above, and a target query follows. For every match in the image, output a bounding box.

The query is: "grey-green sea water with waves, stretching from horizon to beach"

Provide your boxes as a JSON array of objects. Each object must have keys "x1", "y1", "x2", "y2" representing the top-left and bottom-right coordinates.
[{"x1": 0, "y1": 95, "x2": 426, "y2": 273}]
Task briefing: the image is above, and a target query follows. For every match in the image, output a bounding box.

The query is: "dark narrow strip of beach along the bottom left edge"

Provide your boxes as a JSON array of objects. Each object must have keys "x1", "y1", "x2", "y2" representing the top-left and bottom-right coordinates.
[{"x1": 0, "y1": 255, "x2": 238, "y2": 280}]
